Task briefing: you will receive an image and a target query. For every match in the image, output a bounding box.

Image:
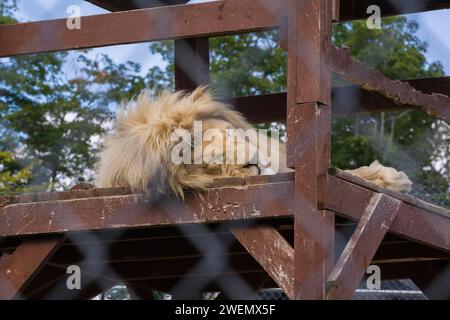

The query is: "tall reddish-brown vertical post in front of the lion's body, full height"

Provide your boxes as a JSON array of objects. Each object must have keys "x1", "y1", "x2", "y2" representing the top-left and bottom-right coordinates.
[{"x1": 287, "y1": 0, "x2": 334, "y2": 299}]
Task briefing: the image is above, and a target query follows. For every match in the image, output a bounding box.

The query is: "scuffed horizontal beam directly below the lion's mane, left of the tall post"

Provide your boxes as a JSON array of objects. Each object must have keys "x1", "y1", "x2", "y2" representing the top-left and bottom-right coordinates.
[{"x1": 0, "y1": 178, "x2": 292, "y2": 236}]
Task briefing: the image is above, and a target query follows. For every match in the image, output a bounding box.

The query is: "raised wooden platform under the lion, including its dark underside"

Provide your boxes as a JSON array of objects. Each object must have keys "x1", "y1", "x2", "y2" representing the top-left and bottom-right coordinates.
[{"x1": 0, "y1": 170, "x2": 450, "y2": 299}]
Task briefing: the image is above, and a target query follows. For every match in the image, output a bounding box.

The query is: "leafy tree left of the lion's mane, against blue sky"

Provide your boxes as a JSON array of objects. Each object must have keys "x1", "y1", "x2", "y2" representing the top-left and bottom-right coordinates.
[{"x1": 0, "y1": 0, "x2": 155, "y2": 192}]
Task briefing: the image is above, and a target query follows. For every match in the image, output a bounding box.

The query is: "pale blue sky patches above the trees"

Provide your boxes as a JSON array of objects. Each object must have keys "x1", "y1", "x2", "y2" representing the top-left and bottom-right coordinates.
[{"x1": 8, "y1": 0, "x2": 450, "y2": 75}]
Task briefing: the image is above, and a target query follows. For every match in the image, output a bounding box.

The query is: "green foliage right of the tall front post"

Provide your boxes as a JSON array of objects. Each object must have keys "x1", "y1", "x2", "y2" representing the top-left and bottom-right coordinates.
[{"x1": 332, "y1": 17, "x2": 450, "y2": 203}]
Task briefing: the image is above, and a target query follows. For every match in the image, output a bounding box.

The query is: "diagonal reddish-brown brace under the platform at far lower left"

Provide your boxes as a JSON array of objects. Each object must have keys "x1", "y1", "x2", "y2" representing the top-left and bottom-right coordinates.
[{"x1": 0, "y1": 236, "x2": 63, "y2": 300}]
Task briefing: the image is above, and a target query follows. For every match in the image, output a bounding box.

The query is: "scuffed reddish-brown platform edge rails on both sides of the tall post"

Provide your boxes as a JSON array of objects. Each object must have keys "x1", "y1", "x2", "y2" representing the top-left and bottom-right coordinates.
[{"x1": 0, "y1": 173, "x2": 450, "y2": 252}]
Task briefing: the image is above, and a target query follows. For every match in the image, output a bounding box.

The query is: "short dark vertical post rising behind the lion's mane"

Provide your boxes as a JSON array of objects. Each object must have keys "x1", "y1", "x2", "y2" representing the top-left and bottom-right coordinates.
[{"x1": 175, "y1": 38, "x2": 209, "y2": 91}]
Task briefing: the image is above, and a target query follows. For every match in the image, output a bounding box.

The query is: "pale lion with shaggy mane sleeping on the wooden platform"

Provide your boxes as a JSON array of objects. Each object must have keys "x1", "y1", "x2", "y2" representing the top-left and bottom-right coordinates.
[{"x1": 96, "y1": 87, "x2": 412, "y2": 199}]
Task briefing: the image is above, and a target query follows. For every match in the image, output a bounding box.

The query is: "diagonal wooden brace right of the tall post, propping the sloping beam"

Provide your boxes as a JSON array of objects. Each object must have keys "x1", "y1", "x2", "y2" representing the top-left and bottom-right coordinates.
[{"x1": 327, "y1": 193, "x2": 401, "y2": 300}]
